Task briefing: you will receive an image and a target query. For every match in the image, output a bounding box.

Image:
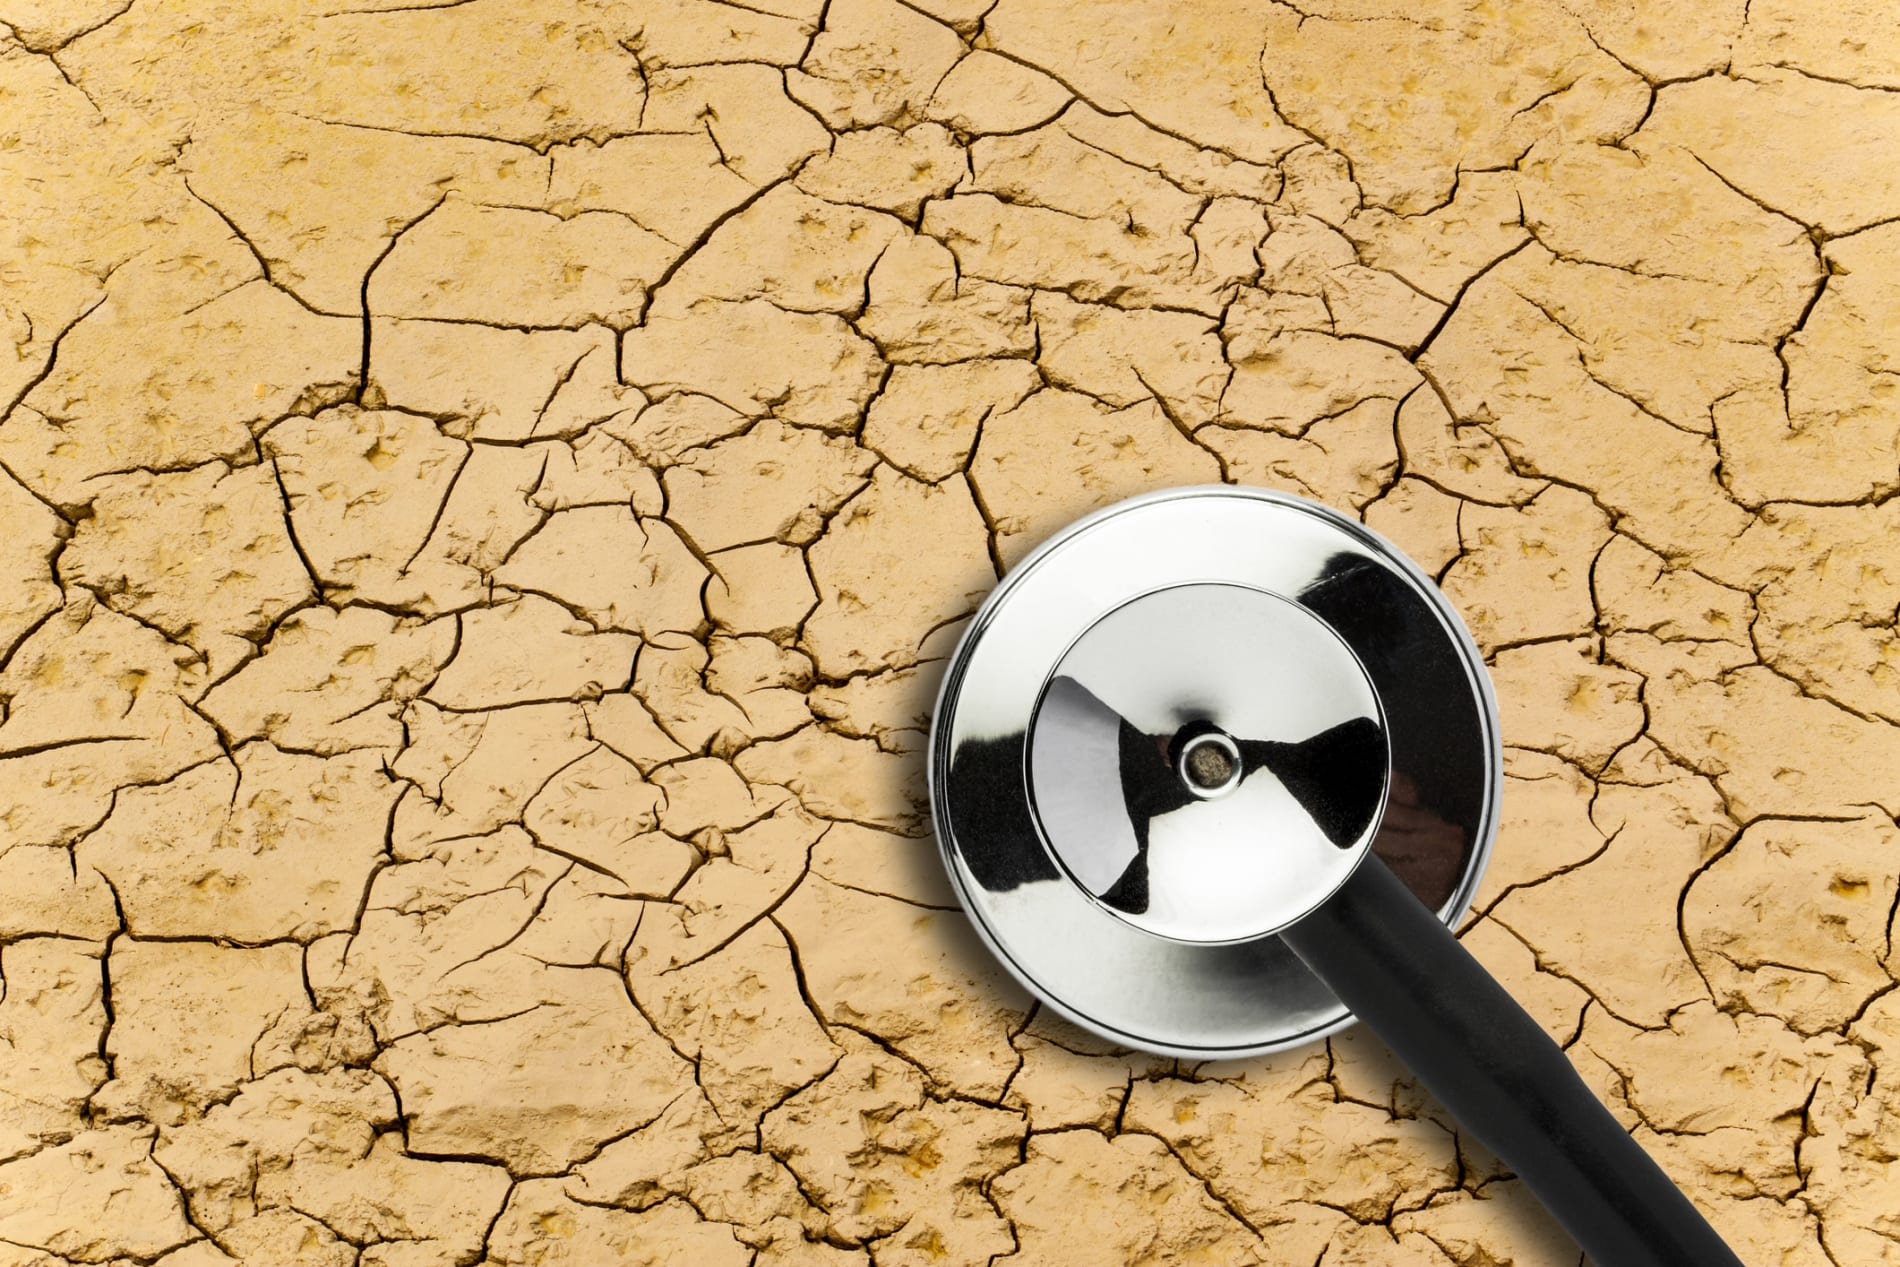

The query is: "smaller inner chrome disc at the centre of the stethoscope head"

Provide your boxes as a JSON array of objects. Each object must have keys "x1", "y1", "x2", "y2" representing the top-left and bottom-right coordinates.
[{"x1": 1028, "y1": 583, "x2": 1391, "y2": 942}]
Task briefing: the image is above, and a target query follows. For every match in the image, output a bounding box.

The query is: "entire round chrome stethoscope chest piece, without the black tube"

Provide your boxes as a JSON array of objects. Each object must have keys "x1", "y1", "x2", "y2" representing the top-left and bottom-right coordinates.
[{"x1": 929, "y1": 486, "x2": 1499, "y2": 1056}]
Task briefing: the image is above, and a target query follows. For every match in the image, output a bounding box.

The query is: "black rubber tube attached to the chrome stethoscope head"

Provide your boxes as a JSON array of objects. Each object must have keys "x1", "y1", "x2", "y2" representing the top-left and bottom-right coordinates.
[{"x1": 1281, "y1": 853, "x2": 1740, "y2": 1267}]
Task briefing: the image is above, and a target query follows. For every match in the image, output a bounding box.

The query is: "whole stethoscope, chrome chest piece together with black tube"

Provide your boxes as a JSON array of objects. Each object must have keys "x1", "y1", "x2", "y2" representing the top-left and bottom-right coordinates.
[{"x1": 929, "y1": 486, "x2": 1740, "y2": 1267}]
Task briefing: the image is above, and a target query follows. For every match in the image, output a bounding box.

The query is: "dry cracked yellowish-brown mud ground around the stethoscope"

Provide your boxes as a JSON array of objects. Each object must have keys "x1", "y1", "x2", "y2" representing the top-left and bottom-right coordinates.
[{"x1": 0, "y1": 0, "x2": 1900, "y2": 1267}]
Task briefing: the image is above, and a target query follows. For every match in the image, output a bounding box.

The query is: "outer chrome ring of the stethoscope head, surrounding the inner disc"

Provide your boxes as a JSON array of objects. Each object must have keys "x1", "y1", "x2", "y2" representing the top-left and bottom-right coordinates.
[{"x1": 929, "y1": 486, "x2": 1501, "y2": 1058}]
